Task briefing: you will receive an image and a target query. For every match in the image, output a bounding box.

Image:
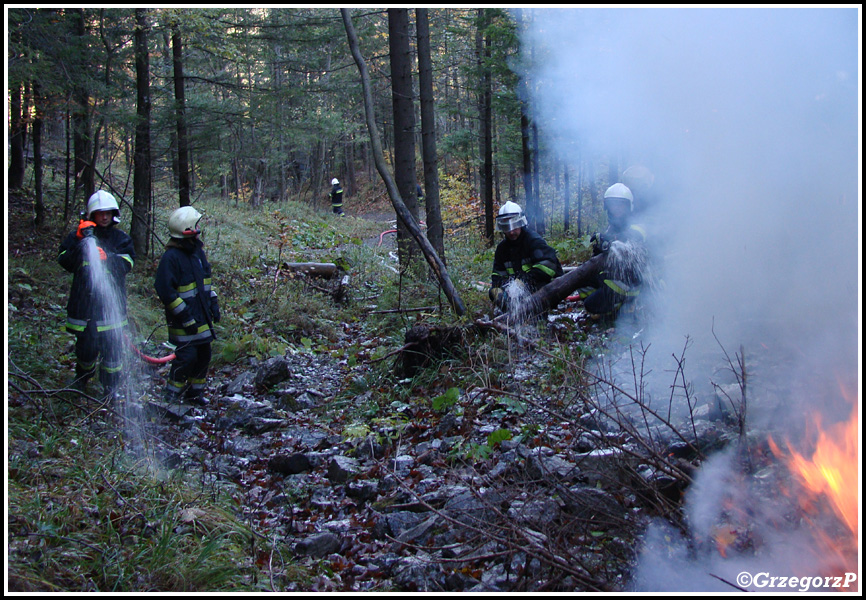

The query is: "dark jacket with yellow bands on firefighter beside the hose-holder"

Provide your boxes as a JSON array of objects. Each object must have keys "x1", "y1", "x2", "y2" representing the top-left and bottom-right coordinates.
[{"x1": 154, "y1": 238, "x2": 220, "y2": 345}]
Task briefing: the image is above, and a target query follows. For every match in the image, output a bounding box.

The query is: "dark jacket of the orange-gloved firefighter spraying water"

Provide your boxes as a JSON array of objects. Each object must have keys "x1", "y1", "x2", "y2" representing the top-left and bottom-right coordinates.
[{"x1": 57, "y1": 225, "x2": 135, "y2": 333}]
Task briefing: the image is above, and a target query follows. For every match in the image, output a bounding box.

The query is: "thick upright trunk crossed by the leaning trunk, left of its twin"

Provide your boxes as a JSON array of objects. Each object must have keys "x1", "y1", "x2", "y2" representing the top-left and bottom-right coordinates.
[{"x1": 388, "y1": 8, "x2": 418, "y2": 269}]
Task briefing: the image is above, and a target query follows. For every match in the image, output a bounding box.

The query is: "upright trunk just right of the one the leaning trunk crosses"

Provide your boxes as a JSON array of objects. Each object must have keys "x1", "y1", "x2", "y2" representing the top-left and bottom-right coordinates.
[{"x1": 415, "y1": 8, "x2": 445, "y2": 264}]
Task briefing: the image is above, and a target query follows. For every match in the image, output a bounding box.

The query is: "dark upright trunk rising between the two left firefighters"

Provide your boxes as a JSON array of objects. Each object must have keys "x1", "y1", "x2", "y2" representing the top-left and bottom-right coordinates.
[{"x1": 129, "y1": 8, "x2": 152, "y2": 256}]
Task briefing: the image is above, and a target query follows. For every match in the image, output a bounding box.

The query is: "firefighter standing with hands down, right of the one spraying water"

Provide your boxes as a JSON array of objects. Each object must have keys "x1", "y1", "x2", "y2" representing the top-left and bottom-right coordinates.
[{"x1": 154, "y1": 206, "x2": 220, "y2": 405}]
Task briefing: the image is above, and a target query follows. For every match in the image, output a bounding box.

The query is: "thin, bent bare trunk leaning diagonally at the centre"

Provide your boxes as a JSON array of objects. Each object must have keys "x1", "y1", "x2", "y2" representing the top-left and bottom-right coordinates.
[{"x1": 340, "y1": 8, "x2": 466, "y2": 315}]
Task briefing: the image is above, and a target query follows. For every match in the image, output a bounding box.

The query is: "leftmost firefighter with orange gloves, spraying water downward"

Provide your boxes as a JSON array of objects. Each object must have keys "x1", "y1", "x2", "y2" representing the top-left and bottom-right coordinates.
[{"x1": 57, "y1": 190, "x2": 135, "y2": 399}]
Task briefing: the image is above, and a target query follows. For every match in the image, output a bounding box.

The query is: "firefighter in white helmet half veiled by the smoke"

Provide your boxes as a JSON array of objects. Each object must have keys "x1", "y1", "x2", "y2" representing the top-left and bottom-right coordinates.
[{"x1": 578, "y1": 183, "x2": 647, "y2": 317}]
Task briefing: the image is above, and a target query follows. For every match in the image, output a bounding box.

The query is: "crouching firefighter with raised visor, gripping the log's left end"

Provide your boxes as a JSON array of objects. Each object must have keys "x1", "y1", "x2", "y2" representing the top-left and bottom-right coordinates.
[{"x1": 488, "y1": 202, "x2": 562, "y2": 311}]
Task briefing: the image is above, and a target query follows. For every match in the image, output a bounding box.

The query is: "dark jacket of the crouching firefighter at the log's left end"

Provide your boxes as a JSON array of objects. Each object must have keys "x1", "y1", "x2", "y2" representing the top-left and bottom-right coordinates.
[{"x1": 491, "y1": 227, "x2": 562, "y2": 292}]
